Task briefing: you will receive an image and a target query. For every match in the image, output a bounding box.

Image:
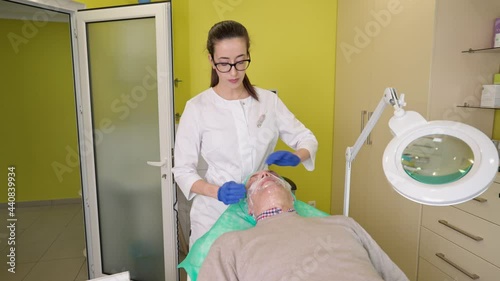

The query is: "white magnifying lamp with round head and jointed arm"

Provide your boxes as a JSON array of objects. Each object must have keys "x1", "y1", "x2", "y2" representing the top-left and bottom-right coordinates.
[{"x1": 344, "y1": 88, "x2": 499, "y2": 216}]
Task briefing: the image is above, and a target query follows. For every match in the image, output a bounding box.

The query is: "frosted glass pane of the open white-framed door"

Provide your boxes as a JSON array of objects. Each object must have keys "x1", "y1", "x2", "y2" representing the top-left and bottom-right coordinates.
[{"x1": 87, "y1": 18, "x2": 163, "y2": 280}]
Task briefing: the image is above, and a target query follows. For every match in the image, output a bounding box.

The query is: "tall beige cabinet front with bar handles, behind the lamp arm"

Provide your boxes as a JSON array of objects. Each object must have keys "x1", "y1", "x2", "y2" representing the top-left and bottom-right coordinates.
[{"x1": 332, "y1": 0, "x2": 434, "y2": 280}]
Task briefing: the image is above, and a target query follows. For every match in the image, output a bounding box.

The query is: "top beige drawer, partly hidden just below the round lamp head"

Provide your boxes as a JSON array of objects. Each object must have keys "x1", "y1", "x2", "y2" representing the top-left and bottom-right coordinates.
[{"x1": 455, "y1": 182, "x2": 500, "y2": 225}]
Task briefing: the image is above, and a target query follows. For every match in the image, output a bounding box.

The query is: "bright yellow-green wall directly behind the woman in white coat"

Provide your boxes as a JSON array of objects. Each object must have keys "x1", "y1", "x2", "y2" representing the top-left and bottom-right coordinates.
[{"x1": 182, "y1": 0, "x2": 337, "y2": 212}]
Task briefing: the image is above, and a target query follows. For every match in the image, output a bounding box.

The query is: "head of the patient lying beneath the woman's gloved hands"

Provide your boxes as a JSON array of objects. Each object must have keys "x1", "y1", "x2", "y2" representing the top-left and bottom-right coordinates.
[{"x1": 245, "y1": 170, "x2": 294, "y2": 215}]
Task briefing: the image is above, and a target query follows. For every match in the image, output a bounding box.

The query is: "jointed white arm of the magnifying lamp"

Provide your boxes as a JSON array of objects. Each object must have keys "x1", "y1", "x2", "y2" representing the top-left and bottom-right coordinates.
[{"x1": 344, "y1": 88, "x2": 405, "y2": 217}]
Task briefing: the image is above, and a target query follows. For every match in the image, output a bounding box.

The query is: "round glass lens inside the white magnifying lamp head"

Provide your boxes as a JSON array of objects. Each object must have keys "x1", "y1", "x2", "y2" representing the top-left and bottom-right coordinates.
[{"x1": 401, "y1": 134, "x2": 474, "y2": 185}]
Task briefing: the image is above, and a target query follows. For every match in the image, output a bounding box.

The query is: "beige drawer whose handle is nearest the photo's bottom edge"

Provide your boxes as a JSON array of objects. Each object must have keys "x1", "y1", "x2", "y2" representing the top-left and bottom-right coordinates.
[{"x1": 419, "y1": 227, "x2": 500, "y2": 281}]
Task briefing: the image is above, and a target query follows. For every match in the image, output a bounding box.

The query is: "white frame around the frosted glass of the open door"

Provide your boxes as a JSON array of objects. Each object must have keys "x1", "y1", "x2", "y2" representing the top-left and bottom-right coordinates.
[{"x1": 76, "y1": 2, "x2": 177, "y2": 280}]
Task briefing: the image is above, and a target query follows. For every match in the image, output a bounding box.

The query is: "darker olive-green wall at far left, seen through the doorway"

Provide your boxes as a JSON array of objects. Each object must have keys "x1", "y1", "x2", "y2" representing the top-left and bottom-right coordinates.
[{"x1": 0, "y1": 20, "x2": 80, "y2": 203}]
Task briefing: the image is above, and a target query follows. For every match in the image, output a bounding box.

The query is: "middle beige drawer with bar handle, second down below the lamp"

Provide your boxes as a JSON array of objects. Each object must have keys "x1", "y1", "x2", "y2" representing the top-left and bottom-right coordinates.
[{"x1": 422, "y1": 203, "x2": 500, "y2": 266}]
